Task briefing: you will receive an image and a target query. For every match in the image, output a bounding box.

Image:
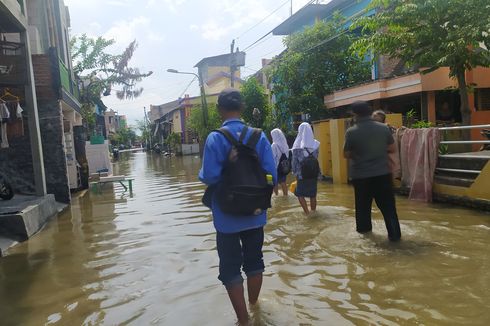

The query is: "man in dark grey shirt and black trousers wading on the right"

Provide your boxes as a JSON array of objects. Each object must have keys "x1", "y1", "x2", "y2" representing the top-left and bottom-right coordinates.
[{"x1": 344, "y1": 102, "x2": 401, "y2": 241}]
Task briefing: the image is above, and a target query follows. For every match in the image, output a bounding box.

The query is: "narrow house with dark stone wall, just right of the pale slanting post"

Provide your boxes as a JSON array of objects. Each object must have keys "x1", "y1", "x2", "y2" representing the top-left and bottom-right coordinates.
[{"x1": 26, "y1": 0, "x2": 88, "y2": 203}]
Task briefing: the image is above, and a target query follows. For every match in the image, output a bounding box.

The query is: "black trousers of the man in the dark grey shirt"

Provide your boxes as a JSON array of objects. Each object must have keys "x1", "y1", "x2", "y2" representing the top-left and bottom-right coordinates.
[{"x1": 352, "y1": 174, "x2": 401, "y2": 241}]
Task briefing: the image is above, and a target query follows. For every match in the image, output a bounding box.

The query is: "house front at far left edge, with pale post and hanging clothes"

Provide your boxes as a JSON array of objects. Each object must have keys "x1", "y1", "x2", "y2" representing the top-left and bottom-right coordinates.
[{"x1": 0, "y1": 0, "x2": 47, "y2": 196}]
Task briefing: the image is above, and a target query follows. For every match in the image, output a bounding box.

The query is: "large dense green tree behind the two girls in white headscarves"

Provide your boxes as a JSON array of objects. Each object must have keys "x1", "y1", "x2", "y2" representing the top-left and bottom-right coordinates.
[{"x1": 271, "y1": 15, "x2": 371, "y2": 120}]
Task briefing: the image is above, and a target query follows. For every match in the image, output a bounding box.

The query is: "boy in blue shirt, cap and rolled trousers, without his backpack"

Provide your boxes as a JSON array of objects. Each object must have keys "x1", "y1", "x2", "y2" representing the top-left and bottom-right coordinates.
[{"x1": 199, "y1": 89, "x2": 277, "y2": 325}]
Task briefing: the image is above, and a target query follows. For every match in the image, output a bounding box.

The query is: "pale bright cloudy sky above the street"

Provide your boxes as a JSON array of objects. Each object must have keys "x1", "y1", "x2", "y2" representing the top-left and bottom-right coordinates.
[{"x1": 65, "y1": 0, "x2": 308, "y2": 124}]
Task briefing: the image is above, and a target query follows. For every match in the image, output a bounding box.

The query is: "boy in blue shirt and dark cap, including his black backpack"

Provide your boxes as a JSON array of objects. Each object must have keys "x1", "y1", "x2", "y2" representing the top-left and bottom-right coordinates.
[{"x1": 199, "y1": 89, "x2": 277, "y2": 325}]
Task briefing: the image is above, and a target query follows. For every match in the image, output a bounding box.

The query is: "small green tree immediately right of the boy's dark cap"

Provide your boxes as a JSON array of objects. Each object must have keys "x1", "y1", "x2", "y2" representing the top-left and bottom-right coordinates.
[{"x1": 241, "y1": 77, "x2": 270, "y2": 128}]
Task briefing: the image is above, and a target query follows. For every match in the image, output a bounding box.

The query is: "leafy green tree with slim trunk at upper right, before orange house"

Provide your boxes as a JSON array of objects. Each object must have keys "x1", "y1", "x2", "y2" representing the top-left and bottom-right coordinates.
[{"x1": 353, "y1": 0, "x2": 490, "y2": 124}]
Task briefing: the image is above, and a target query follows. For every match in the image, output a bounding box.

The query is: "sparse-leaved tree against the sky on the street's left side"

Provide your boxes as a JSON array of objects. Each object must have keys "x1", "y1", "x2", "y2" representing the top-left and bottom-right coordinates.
[{"x1": 70, "y1": 34, "x2": 152, "y2": 131}]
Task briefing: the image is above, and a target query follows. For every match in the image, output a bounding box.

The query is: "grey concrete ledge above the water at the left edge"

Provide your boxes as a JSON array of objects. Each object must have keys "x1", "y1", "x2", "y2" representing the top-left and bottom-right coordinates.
[{"x1": 0, "y1": 195, "x2": 59, "y2": 241}]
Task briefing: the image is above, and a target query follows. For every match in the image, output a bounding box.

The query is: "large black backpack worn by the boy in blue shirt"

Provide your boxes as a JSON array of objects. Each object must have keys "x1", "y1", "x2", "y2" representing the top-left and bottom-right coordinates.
[{"x1": 215, "y1": 126, "x2": 273, "y2": 216}]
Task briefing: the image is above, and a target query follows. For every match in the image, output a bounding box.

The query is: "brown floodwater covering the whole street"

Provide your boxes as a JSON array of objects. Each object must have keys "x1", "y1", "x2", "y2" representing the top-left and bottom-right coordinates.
[{"x1": 0, "y1": 153, "x2": 490, "y2": 325}]
